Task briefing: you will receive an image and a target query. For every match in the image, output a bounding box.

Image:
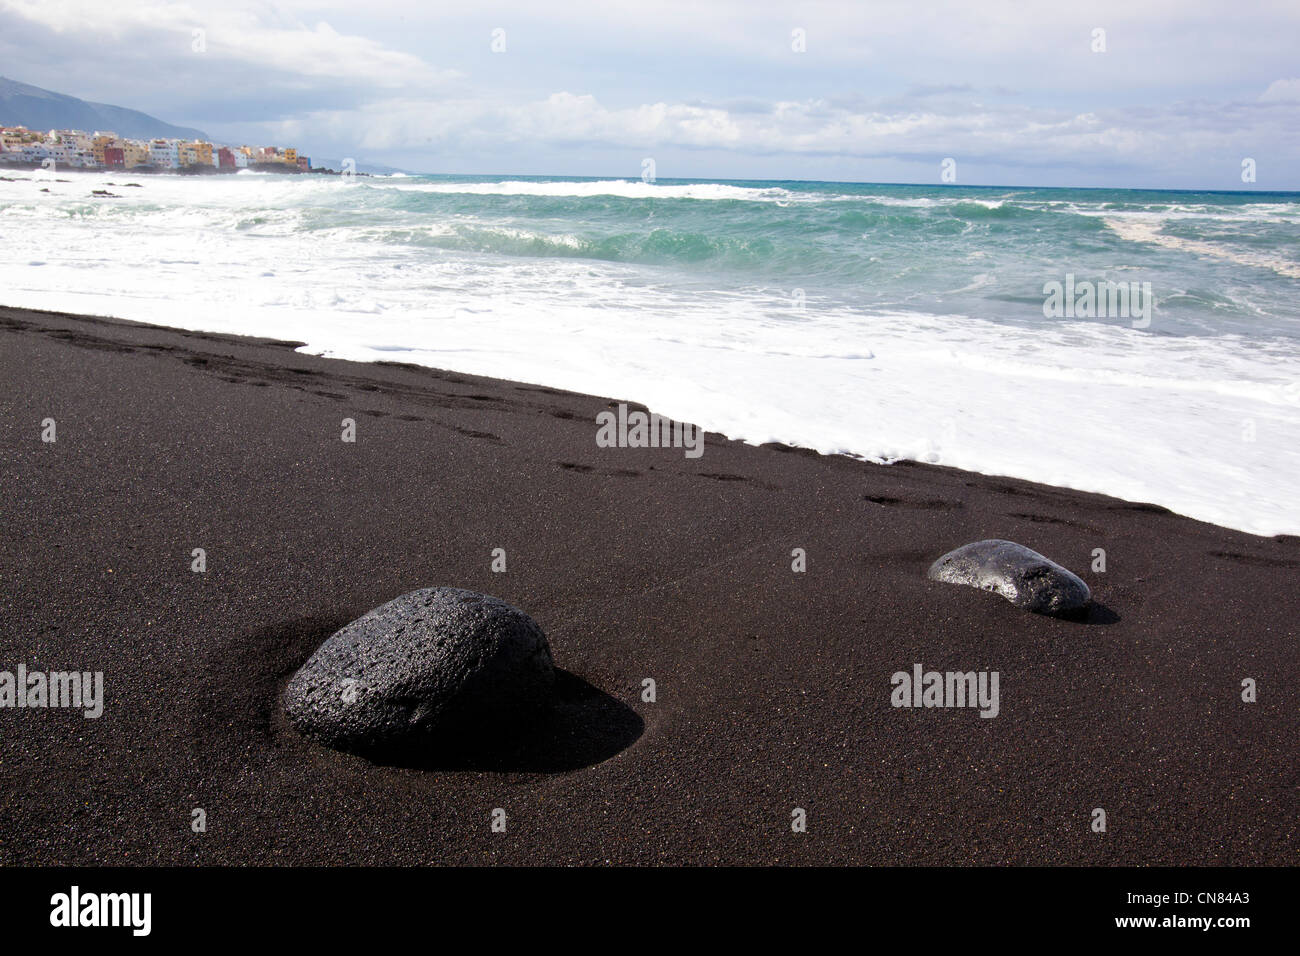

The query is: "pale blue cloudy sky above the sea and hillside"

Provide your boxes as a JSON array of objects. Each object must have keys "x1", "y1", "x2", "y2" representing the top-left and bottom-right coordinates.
[{"x1": 0, "y1": 0, "x2": 1300, "y2": 190}]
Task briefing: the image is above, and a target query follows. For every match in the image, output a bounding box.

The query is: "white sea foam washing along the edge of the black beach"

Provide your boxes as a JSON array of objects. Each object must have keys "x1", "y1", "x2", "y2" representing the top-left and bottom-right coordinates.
[{"x1": 0, "y1": 173, "x2": 1300, "y2": 535}]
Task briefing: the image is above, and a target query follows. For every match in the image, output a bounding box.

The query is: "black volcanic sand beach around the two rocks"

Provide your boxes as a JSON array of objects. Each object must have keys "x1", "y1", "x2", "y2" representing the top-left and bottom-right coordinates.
[{"x1": 0, "y1": 308, "x2": 1300, "y2": 865}]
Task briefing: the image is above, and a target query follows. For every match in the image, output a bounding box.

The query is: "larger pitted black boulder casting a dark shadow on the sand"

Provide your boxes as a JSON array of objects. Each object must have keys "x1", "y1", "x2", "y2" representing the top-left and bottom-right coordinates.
[{"x1": 285, "y1": 588, "x2": 555, "y2": 754}]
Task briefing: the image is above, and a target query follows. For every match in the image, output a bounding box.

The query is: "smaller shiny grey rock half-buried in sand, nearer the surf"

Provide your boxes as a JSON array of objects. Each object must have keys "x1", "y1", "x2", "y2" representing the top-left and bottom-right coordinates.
[{"x1": 928, "y1": 538, "x2": 1092, "y2": 615}]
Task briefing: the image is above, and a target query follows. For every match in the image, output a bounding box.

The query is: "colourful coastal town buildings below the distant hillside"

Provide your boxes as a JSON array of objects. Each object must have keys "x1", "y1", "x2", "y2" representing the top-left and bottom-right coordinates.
[{"x1": 0, "y1": 126, "x2": 314, "y2": 173}]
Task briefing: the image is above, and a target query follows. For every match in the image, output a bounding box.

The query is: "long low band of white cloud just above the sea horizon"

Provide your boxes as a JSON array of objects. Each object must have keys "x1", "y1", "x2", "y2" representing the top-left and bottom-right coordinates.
[{"x1": 244, "y1": 92, "x2": 1300, "y2": 174}]
